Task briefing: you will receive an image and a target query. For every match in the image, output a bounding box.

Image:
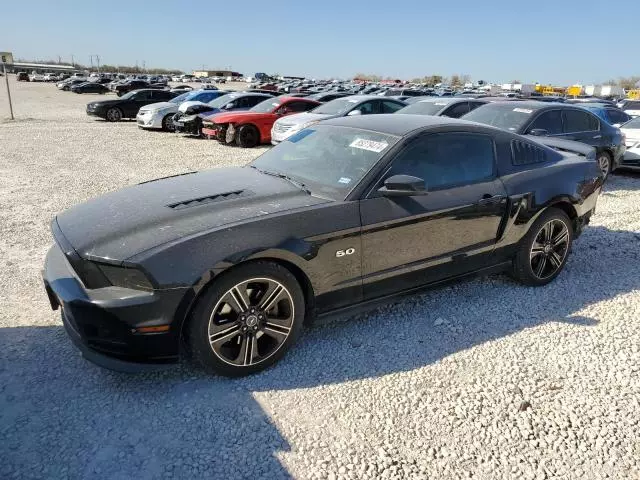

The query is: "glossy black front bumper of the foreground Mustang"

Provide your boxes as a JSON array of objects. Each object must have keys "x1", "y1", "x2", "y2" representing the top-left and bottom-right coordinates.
[{"x1": 43, "y1": 244, "x2": 187, "y2": 372}]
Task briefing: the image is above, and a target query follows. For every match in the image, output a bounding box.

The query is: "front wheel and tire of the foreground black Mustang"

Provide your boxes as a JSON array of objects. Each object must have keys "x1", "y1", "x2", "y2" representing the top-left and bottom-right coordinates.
[{"x1": 186, "y1": 261, "x2": 305, "y2": 377}]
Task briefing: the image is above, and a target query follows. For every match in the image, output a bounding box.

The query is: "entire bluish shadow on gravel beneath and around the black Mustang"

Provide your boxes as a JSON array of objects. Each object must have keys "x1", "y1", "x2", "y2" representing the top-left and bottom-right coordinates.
[{"x1": 0, "y1": 227, "x2": 640, "y2": 479}]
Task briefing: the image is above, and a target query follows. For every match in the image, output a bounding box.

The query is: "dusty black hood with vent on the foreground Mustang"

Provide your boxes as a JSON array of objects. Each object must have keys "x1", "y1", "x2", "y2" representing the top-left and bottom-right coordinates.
[{"x1": 57, "y1": 167, "x2": 328, "y2": 261}]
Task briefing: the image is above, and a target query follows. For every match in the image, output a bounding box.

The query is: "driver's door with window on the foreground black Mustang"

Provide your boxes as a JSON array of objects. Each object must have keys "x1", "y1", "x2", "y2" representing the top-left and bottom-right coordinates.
[{"x1": 360, "y1": 132, "x2": 507, "y2": 299}]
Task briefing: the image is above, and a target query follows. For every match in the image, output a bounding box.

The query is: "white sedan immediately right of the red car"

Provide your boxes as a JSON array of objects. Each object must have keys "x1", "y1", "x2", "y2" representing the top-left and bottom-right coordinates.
[{"x1": 271, "y1": 95, "x2": 406, "y2": 145}]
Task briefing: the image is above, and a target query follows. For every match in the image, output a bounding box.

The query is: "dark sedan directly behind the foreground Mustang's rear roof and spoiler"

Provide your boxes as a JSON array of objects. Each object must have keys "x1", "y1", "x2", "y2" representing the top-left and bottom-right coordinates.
[{"x1": 462, "y1": 101, "x2": 625, "y2": 178}]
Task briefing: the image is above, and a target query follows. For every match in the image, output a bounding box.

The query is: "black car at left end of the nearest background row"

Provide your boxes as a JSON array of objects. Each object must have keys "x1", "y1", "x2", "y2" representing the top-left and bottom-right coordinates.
[{"x1": 87, "y1": 89, "x2": 179, "y2": 122}]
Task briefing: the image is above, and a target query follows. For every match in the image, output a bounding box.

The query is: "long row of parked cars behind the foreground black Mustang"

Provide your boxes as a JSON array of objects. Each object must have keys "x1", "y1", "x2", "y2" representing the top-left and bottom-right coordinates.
[{"x1": 67, "y1": 82, "x2": 640, "y2": 176}]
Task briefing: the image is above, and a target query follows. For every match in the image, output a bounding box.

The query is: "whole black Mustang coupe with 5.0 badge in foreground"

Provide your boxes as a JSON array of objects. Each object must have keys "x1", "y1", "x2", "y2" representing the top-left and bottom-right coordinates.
[{"x1": 44, "y1": 115, "x2": 602, "y2": 376}]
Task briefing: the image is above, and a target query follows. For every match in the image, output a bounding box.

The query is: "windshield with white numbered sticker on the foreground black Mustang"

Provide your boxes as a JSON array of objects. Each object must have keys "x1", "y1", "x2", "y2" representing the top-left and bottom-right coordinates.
[{"x1": 252, "y1": 125, "x2": 399, "y2": 200}]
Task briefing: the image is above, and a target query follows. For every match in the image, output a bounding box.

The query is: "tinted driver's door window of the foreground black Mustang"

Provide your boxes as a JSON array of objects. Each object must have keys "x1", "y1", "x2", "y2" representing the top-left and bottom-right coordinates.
[{"x1": 385, "y1": 133, "x2": 495, "y2": 190}]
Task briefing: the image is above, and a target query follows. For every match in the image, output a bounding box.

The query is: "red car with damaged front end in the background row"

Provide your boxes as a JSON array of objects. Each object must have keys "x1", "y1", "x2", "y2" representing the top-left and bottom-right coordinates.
[{"x1": 202, "y1": 97, "x2": 320, "y2": 147}]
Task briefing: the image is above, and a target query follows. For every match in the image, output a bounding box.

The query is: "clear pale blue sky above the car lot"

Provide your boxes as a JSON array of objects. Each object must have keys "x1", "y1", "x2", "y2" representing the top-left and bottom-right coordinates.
[{"x1": 0, "y1": 0, "x2": 640, "y2": 84}]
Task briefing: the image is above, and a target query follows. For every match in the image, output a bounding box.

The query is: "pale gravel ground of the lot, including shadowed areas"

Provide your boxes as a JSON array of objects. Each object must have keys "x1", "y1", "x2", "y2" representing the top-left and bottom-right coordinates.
[{"x1": 0, "y1": 77, "x2": 640, "y2": 479}]
